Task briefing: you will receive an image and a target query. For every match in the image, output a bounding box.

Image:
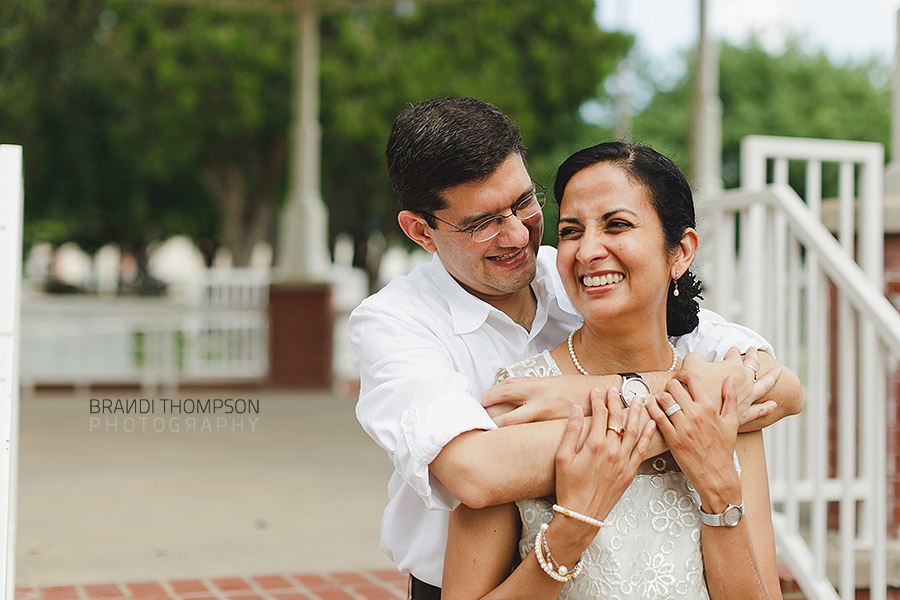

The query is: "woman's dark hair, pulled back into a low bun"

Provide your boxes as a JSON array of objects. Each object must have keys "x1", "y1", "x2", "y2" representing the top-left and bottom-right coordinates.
[{"x1": 553, "y1": 142, "x2": 703, "y2": 335}]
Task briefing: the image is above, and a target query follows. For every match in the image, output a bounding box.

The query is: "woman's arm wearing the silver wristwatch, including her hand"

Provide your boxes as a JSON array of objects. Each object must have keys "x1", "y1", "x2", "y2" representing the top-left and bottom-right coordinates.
[{"x1": 648, "y1": 376, "x2": 781, "y2": 600}]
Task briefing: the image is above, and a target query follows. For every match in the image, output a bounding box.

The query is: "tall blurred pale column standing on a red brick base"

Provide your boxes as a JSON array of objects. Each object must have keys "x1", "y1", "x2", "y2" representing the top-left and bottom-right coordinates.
[{"x1": 277, "y1": 1, "x2": 330, "y2": 283}]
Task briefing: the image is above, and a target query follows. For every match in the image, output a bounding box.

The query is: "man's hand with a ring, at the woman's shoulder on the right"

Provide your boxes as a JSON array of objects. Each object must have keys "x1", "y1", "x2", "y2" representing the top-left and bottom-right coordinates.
[{"x1": 681, "y1": 348, "x2": 782, "y2": 431}]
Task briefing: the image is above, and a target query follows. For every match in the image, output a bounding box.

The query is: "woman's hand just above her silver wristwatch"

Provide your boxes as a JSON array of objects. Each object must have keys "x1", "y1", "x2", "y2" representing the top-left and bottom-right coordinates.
[{"x1": 647, "y1": 373, "x2": 741, "y2": 513}]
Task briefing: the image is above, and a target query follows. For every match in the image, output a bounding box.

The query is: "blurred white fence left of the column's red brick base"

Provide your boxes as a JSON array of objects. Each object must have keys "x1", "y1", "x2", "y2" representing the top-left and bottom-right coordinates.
[{"x1": 21, "y1": 269, "x2": 269, "y2": 389}]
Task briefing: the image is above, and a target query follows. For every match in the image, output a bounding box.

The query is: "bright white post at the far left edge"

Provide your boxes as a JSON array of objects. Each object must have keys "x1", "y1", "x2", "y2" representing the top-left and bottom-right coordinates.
[{"x1": 0, "y1": 146, "x2": 23, "y2": 600}]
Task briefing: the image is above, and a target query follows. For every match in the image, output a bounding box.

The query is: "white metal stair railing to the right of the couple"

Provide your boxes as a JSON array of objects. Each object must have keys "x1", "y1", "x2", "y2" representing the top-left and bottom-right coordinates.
[{"x1": 709, "y1": 136, "x2": 900, "y2": 600}]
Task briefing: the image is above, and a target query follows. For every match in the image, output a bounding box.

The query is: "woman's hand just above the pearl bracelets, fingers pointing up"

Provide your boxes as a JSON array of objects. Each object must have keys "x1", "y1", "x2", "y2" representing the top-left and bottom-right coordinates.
[{"x1": 556, "y1": 388, "x2": 655, "y2": 535}]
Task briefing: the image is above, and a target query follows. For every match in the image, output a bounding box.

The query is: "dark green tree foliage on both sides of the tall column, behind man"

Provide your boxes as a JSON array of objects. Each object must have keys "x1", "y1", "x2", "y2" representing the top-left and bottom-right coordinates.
[{"x1": 0, "y1": 0, "x2": 631, "y2": 290}]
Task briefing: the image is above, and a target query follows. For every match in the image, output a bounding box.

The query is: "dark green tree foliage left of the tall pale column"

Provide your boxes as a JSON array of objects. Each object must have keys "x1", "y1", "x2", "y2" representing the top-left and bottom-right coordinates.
[{"x1": 0, "y1": 0, "x2": 292, "y2": 288}]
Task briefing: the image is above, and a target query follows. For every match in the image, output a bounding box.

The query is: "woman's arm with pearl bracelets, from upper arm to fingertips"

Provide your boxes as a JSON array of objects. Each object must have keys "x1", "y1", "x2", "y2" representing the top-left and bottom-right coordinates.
[{"x1": 441, "y1": 392, "x2": 655, "y2": 600}]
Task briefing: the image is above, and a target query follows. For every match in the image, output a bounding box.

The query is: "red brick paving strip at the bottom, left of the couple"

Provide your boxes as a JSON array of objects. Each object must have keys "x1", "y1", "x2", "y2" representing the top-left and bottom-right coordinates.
[{"x1": 16, "y1": 570, "x2": 406, "y2": 600}]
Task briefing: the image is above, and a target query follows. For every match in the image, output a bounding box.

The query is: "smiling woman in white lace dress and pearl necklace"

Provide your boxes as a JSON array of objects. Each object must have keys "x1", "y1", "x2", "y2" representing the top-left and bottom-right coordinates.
[{"x1": 442, "y1": 142, "x2": 781, "y2": 600}]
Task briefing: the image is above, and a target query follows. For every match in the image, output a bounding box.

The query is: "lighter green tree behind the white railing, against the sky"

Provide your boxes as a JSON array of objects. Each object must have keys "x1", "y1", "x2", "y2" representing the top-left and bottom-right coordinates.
[{"x1": 633, "y1": 39, "x2": 890, "y2": 194}]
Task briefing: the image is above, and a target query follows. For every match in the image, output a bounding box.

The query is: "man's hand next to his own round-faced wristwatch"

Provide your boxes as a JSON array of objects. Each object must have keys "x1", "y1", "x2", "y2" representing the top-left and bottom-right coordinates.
[{"x1": 481, "y1": 375, "x2": 591, "y2": 427}]
